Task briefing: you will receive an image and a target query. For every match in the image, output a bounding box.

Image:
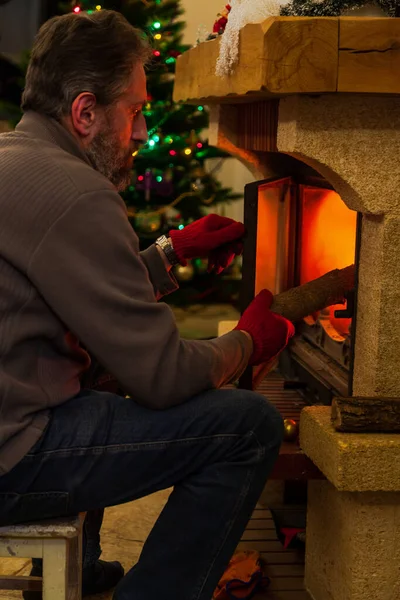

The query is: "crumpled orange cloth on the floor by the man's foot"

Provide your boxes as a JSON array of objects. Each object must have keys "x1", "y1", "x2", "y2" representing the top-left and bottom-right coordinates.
[{"x1": 213, "y1": 550, "x2": 269, "y2": 600}]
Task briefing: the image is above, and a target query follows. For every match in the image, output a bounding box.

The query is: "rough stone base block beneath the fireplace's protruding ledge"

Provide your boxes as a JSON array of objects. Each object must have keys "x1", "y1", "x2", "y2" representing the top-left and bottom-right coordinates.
[{"x1": 305, "y1": 481, "x2": 400, "y2": 600}]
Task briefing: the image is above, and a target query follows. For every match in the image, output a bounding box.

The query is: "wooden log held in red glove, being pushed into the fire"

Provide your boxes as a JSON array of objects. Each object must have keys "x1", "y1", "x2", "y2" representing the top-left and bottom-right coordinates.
[{"x1": 253, "y1": 265, "x2": 355, "y2": 389}]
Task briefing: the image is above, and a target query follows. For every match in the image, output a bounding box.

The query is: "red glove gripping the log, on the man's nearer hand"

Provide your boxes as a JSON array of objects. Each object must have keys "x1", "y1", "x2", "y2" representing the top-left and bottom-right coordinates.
[{"x1": 235, "y1": 290, "x2": 295, "y2": 365}]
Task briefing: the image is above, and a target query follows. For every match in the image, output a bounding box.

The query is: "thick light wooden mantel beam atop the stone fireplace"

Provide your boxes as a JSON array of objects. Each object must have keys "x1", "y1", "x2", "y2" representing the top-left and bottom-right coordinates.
[{"x1": 174, "y1": 17, "x2": 400, "y2": 104}]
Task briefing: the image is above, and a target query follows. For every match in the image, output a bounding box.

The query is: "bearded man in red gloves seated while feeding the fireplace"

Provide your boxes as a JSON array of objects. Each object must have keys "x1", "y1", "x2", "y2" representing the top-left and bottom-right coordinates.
[{"x1": 0, "y1": 10, "x2": 293, "y2": 600}]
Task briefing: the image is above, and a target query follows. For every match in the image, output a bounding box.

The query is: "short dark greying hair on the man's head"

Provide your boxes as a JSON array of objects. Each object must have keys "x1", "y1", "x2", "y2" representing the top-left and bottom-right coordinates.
[{"x1": 21, "y1": 10, "x2": 151, "y2": 121}]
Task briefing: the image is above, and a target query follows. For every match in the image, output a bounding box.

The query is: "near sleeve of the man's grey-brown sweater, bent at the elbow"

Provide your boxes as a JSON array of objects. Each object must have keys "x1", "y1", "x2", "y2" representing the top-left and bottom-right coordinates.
[{"x1": 28, "y1": 190, "x2": 252, "y2": 409}]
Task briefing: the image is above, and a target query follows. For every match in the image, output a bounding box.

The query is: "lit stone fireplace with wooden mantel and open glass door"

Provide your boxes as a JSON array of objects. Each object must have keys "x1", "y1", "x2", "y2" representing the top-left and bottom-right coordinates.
[{"x1": 175, "y1": 17, "x2": 400, "y2": 600}]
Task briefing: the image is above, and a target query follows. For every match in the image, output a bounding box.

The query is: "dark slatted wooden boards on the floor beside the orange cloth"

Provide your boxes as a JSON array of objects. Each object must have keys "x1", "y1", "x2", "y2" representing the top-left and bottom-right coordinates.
[{"x1": 237, "y1": 506, "x2": 311, "y2": 600}]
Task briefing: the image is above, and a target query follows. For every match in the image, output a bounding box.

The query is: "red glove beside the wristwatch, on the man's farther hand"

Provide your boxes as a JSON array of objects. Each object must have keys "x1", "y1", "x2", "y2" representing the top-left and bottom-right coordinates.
[{"x1": 169, "y1": 215, "x2": 245, "y2": 273}]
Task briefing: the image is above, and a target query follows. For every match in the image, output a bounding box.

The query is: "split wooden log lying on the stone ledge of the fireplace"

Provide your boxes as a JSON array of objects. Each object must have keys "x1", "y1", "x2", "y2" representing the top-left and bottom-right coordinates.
[{"x1": 332, "y1": 397, "x2": 400, "y2": 433}]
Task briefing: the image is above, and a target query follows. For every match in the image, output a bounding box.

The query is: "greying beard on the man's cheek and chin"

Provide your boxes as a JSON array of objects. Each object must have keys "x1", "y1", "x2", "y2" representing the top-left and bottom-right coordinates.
[{"x1": 86, "y1": 130, "x2": 132, "y2": 192}]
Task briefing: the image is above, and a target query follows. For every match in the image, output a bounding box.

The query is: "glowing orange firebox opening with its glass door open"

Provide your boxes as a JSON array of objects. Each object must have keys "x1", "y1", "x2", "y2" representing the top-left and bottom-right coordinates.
[{"x1": 241, "y1": 176, "x2": 361, "y2": 404}]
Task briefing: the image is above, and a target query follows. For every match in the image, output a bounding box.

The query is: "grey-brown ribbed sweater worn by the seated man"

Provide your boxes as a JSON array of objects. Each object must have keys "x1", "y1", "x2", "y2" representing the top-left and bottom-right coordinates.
[{"x1": 0, "y1": 112, "x2": 252, "y2": 475}]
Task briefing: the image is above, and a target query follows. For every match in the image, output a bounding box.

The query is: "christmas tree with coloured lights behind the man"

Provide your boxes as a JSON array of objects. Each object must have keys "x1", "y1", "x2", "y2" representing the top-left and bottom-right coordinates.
[{"x1": 60, "y1": 0, "x2": 241, "y2": 304}]
